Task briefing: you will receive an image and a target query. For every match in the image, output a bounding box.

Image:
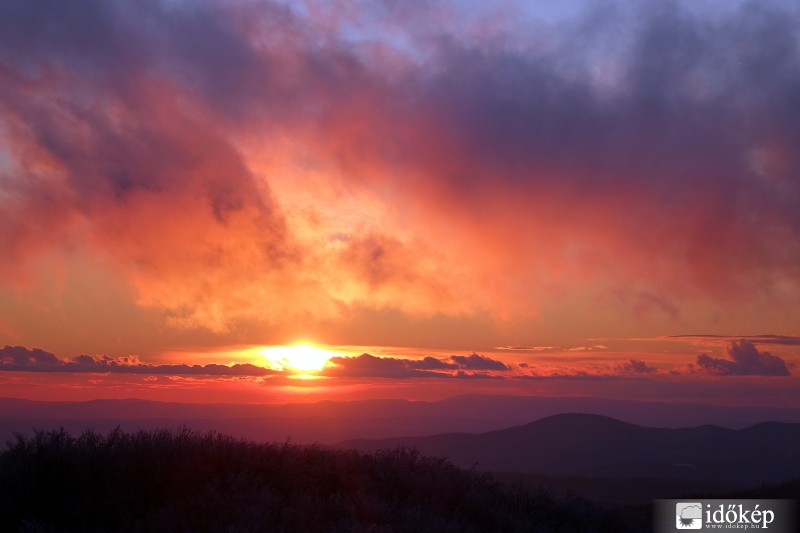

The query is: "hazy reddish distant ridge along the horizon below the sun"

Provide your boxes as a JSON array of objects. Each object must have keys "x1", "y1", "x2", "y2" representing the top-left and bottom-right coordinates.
[{"x1": 0, "y1": 395, "x2": 800, "y2": 444}]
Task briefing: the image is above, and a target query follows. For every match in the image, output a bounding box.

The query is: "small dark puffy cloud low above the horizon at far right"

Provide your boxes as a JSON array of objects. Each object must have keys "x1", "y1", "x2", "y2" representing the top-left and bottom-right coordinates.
[{"x1": 697, "y1": 340, "x2": 790, "y2": 376}]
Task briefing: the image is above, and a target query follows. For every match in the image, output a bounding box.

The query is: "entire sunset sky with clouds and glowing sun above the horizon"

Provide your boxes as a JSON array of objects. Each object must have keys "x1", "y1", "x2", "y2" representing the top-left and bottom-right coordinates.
[{"x1": 0, "y1": 0, "x2": 800, "y2": 407}]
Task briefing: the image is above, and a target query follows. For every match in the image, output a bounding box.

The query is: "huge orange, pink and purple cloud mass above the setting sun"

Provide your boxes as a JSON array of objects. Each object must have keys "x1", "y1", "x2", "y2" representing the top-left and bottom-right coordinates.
[{"x1": 0, "y1": 1, "x2": 800, "y2": 340}]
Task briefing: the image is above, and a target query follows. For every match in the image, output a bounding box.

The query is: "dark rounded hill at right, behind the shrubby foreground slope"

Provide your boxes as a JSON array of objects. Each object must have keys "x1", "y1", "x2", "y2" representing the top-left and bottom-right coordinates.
[{"x1": 338, "y1": 414, "x2": 800, "y2": 499}]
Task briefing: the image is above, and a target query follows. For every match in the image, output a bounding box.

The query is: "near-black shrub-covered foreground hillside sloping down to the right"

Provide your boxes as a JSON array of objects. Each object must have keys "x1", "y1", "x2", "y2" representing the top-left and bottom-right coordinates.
[{"x1": 0, "y1": 429, "x2": 648, "y2": 532}]
